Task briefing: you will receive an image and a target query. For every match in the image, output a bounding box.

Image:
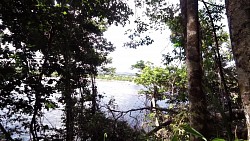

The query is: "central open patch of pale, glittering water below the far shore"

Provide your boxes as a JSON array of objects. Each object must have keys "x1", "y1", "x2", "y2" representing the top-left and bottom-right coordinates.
[{"x1": 97, "y1": 80, "x2": 146, "y2": 126}]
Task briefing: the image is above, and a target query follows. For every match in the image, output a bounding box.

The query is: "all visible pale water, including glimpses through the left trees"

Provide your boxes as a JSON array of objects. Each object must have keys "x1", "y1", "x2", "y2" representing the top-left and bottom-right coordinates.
[{"x1": 0, "y1": 80, "x2": 146, "y2": 141}]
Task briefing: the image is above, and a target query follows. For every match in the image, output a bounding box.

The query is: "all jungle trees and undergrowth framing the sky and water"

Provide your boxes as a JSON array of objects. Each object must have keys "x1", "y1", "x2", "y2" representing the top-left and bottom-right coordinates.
[{"x1": 0, "y1": 0, "x2": 250, "y2": 141}]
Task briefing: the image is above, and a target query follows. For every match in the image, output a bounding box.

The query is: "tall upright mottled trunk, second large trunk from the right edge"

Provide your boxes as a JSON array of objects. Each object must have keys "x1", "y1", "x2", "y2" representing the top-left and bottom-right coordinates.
[{"x1": 186, "y1": 0, "x2": 207, "y2": 141}]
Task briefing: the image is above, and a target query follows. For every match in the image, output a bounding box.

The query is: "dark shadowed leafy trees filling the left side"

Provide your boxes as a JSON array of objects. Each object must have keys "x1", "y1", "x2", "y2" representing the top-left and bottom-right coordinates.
[{"x1": 0, "y1": 0, "x2": 131, "y2": 141}]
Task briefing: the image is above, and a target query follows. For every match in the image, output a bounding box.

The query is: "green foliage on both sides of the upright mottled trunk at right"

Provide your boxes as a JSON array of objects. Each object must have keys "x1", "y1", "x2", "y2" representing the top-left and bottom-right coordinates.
[{"x1": 127, "y1": 0, "x2": 246, "y2": 140}]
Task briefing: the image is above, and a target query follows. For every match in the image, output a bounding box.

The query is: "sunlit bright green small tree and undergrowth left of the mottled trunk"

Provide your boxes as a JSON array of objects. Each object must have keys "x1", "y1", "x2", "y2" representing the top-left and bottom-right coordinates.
[{"x1": 132, "y1": 61, "x2": 188, "y2": 140}]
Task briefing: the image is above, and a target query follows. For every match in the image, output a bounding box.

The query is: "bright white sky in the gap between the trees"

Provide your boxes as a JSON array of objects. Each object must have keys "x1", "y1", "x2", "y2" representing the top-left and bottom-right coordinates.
[{"x1": 104, "y1": 0, "x2": 175, "y2": 73}]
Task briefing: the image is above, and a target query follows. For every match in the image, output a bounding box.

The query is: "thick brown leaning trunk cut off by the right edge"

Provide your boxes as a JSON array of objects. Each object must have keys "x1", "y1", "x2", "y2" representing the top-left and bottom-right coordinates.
[{"x1": 226, "y1": 0, "x2": 250, "y2": 140}]
